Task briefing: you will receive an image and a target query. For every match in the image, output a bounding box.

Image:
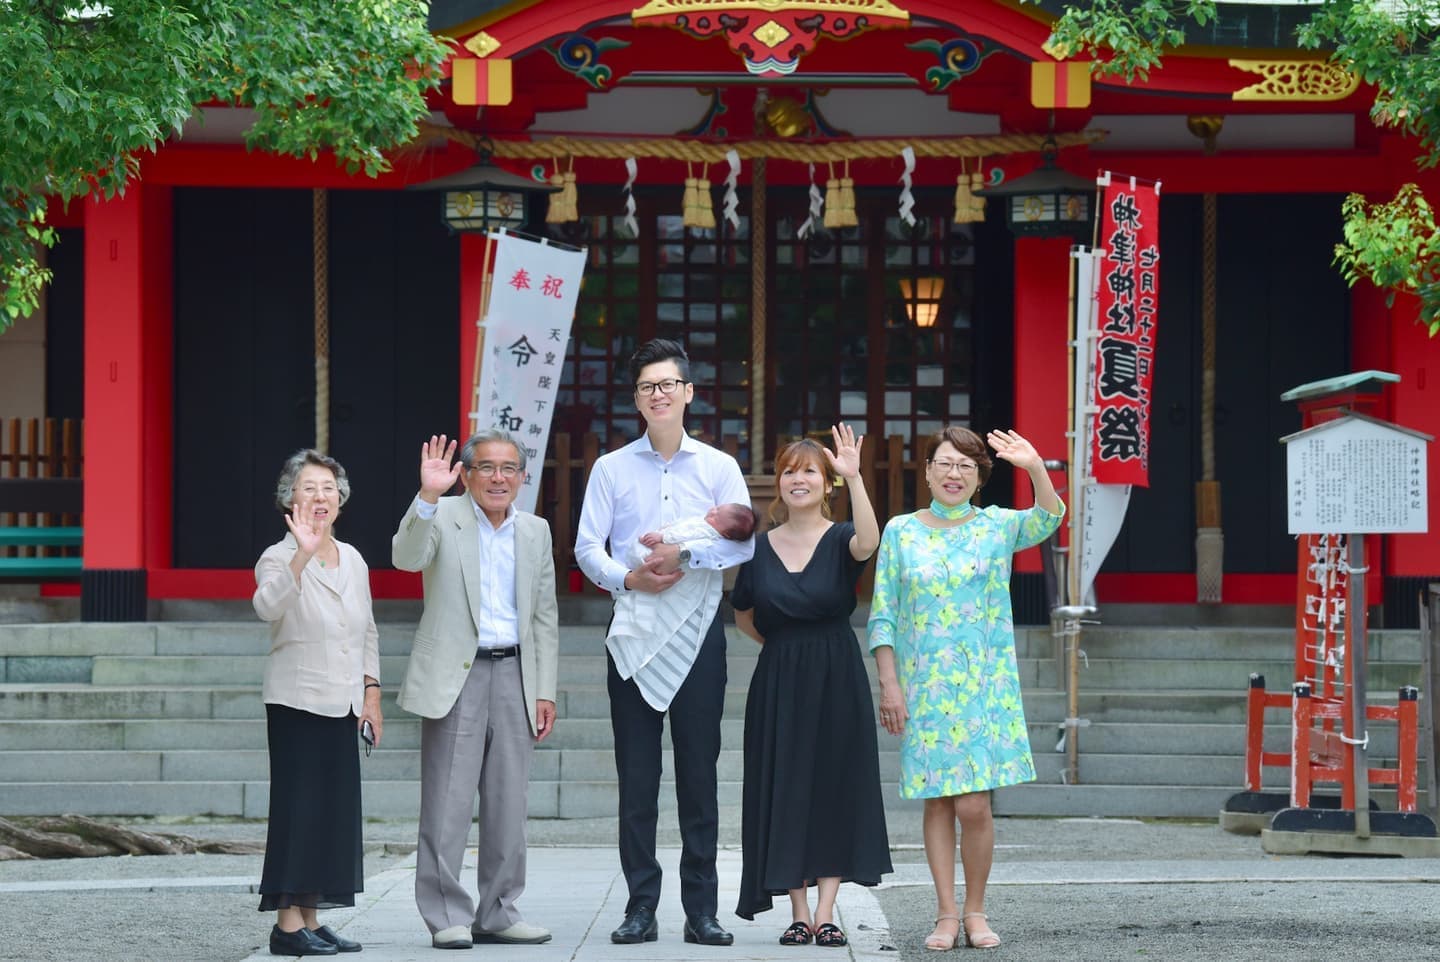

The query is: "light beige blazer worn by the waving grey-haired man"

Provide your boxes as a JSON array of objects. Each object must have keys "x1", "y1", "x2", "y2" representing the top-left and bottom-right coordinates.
[{"x1": 390, "y1": 494, "x2": 560, "y2": 733}]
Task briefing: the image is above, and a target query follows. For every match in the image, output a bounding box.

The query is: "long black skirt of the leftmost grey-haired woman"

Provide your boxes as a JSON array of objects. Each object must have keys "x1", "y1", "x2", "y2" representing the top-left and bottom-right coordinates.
[{"x1": 261, "y1": 704, "x2": 364, "y2": 912}]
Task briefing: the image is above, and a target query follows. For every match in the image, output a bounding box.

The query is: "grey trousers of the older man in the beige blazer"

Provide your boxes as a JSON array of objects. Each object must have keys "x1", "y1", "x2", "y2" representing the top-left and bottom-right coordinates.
[{"x1": 415, "y1": 654, "x2": 536, "y2": 935}]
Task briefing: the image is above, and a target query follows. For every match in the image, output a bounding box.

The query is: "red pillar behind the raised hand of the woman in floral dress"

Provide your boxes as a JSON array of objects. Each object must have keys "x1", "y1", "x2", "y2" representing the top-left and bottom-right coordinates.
[{"x1": 1013, "y1": 238, "x2": 1074, "y2": 572}]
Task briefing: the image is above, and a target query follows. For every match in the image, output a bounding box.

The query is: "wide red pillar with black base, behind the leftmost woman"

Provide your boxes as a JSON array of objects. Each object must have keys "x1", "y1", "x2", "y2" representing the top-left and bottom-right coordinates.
[{"x1": 81, "y1": 181, "x2": 171, "y2": 621}]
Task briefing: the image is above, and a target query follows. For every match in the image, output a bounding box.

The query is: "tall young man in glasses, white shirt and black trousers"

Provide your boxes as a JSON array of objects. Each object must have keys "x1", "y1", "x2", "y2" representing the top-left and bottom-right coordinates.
[{"x1": 575, "y1": 338, "x2": 755, "y2": 945}]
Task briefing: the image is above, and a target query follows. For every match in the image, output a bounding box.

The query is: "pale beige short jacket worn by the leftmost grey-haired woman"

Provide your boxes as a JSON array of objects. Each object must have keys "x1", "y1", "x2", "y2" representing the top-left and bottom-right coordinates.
[{"x1": 252, "y1": 534, "x2": 380, "y2": 719}]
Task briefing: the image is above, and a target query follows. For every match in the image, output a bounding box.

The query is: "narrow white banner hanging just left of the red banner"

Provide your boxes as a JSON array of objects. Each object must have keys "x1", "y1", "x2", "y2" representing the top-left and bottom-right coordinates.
[{"x1": 1071, "y1": 248, "x2": 1130, "y2": 605}]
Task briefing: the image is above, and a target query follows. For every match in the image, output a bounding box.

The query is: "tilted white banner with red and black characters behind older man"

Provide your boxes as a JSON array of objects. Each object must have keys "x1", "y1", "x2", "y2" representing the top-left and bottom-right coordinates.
[{"x1": 469, "y1": 230, "x2": 585, "y2": 513}]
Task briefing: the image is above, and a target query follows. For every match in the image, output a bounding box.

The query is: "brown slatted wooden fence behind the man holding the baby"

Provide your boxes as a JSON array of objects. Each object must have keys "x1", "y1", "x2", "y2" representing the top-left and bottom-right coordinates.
[{"x1": 537, "y1": 433, "x2": 930, "y2": 593}]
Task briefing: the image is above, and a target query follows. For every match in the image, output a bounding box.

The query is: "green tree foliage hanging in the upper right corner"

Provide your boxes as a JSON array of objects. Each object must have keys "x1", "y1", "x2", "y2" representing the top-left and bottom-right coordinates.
[{"x1": 1050, "y1": 0, "x2": 1440, "y2": 337}]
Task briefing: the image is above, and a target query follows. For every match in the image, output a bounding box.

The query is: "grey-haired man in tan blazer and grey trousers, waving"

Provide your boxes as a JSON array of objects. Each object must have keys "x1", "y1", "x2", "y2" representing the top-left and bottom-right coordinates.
[{"x1": 390, "y1": 431, "x2": 560, "y2": 949}]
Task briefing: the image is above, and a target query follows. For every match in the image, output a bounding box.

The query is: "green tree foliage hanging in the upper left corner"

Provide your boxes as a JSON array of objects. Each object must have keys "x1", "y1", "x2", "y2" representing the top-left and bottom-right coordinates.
[{"x1": 0, "y1": 0, "x2": 446, "y2": 331}]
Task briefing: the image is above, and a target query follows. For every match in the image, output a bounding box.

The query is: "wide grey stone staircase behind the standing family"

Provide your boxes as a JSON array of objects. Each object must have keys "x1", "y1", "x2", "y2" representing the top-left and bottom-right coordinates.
[{"x1": 0, "y1": 598, "x2": 1420, "y2": 818}]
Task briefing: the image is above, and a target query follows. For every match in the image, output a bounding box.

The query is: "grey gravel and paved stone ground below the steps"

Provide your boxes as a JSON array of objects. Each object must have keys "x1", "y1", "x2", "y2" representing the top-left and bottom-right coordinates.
[{"x1": 0, "y1": 809, "x2": 1440, "y2": 962}]
